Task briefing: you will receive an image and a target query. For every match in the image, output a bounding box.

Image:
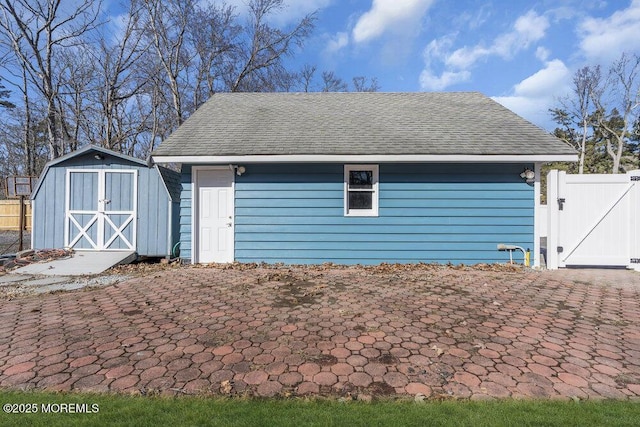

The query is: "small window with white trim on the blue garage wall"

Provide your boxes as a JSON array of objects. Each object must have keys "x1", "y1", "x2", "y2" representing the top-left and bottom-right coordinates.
[{"x1": 344, "y1": 165, "x2": 378, "y2": 216}]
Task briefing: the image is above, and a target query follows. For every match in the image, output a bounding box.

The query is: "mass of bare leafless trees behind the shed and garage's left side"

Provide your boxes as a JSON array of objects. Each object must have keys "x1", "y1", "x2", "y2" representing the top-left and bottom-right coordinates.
[{"x1": 0, "y1": 0, "x2": 320, "y2": 164}]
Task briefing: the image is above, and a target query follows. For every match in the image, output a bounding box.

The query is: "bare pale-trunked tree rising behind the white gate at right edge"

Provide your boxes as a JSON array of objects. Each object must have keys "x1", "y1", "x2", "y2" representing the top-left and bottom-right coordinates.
[{"x1": 591, "y1": 54, "x2": 640, "y2": 173}]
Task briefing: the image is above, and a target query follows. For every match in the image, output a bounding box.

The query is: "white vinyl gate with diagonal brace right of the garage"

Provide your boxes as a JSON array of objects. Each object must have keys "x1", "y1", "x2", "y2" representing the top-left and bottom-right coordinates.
[{"x1": 547, "y1": 170, "x2": 640, "y2": 270}]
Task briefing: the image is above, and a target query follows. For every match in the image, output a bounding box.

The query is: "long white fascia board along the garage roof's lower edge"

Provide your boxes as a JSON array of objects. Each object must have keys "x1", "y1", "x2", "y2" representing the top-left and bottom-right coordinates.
[{"x1": 152, "y1": 154, "x2": 578, "y2": 165}]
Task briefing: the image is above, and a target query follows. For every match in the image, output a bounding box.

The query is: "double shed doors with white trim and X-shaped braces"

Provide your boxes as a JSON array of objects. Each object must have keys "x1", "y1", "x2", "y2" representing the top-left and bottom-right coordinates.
[{"x1": 65, "y1": 169, "x2": 138, "y2": 250}]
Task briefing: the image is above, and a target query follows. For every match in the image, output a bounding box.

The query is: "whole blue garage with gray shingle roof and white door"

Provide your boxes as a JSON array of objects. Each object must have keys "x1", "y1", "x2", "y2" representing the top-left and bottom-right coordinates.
[{"x1": 152, "y1": 92, "x2": 577, "y2": 266}]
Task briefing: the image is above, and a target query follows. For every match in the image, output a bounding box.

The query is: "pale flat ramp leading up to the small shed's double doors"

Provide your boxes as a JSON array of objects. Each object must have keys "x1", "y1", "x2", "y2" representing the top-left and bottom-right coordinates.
[{"x1": 13, "y1": 251, "x2": 136, "y2": 276}]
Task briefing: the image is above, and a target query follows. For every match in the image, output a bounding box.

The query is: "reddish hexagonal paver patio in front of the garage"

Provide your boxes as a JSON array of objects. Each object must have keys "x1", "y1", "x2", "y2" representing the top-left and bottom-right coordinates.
[{"x1": 0, "y1": 266, "x2": 640, "y2": 399}]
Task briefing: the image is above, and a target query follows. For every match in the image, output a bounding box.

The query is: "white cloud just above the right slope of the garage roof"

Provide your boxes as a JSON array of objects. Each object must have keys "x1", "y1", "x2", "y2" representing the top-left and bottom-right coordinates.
[{"x1": 493, "y1": 59, "x2": 571, "y2": 131}]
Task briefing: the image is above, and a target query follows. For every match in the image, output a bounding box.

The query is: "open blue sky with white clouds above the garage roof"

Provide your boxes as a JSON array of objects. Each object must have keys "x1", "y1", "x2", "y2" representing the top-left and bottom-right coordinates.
[{"x1": 218, "y1": 0, "x2": 640, "y2": 130}]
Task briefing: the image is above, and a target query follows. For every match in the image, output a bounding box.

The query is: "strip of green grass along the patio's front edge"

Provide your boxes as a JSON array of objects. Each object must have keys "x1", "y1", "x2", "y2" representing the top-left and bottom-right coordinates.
[{"x1": 0, "y1": 391, "x2": 640, "y2": 427}]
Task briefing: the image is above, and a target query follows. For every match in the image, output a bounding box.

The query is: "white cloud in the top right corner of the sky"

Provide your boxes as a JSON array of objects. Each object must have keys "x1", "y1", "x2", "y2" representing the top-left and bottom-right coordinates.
[{"x1": 578, "y1": 0, "x2": 640, "y2": 62}]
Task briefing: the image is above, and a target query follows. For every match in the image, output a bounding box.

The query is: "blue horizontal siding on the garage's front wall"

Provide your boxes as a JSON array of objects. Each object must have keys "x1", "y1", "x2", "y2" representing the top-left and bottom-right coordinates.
[{"x1": 231, "y1": 164, "x2": 534, "y2": 264}]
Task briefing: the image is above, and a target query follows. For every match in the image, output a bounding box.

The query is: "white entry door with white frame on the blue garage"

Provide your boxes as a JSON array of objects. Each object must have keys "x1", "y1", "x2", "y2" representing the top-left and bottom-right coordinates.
[{"x1": 194, "y1": 169, "x2": 234, "y2": 263}]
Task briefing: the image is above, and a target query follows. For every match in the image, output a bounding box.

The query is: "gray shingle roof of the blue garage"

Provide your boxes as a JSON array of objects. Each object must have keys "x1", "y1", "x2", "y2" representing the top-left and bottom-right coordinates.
[{"x1": 153, "y1": 92, "x2": 575, "y2": 156}]
